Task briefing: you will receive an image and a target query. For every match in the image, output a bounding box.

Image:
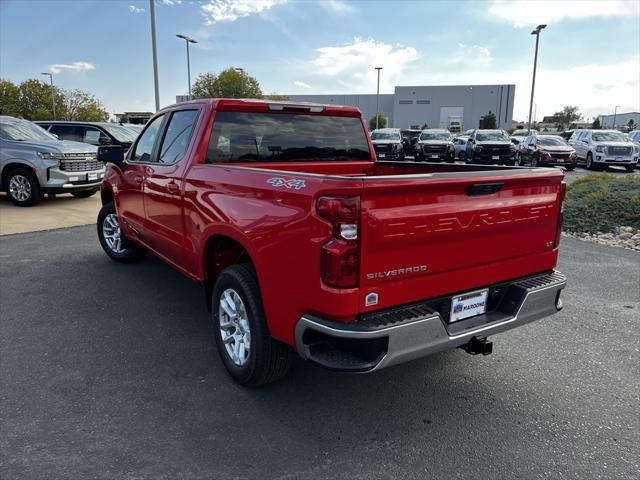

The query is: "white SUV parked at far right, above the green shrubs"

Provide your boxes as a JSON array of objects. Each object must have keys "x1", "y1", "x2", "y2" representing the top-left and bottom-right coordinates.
[{"x1": 569, "y1": 130, "x2": 640, "y2": 172}]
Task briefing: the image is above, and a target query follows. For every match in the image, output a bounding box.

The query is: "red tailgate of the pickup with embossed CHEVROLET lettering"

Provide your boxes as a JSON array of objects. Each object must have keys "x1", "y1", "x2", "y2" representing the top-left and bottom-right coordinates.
[{"x1": 360, "y1": 169, "x2": 563, "y2": 311}]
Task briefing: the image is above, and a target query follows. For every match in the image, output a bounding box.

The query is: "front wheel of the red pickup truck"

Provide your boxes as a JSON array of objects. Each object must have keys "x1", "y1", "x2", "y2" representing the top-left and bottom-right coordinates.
[{"x1": 97, "y1": 203, "x2": 146, "y2": 263}]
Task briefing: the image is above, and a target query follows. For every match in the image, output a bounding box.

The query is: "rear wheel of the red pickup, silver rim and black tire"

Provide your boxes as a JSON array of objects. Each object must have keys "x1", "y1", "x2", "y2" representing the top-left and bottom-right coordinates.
[{"x1": 211, "y1": 264, "x2": 293, "y2": 387}]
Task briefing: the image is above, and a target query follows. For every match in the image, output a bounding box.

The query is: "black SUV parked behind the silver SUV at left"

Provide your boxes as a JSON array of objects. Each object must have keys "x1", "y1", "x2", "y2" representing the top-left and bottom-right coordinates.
[{"x1": 35, "y1": 121, "x2": 137, "y2": 151}]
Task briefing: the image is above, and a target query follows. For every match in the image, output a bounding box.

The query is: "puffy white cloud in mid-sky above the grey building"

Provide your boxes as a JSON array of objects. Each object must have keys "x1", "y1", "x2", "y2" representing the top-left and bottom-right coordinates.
[{"x1": 312, "y1": 37, "x2": 420, "y2": 92}]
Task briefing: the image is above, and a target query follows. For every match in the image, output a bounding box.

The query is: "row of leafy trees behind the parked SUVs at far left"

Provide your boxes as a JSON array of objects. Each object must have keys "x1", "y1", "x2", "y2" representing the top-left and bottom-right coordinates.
[{"x1": 0, "y1": 79, "x2": 109, "y2": 122}]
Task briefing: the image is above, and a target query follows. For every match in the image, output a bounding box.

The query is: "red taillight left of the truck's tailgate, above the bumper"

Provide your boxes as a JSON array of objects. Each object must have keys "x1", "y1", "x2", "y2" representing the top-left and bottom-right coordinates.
[{"x1": 316, "y1": 197, "x2": 360, "y2": 288}]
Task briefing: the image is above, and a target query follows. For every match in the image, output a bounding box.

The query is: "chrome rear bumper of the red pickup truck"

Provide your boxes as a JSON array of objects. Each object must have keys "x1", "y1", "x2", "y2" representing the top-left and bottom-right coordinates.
[{"x1": 295, "y1": 270, "x2": 566, "y2": 372}]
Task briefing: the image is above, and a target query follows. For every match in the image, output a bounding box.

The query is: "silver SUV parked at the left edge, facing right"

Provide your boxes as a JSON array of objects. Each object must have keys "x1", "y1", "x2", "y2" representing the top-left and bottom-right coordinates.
[{"x1": 0, "y1": 116, "x2": 105, "y2": 207}]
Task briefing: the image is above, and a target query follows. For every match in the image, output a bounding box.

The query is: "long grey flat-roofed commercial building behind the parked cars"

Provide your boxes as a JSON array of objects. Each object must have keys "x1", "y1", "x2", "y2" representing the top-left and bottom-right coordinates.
[{"x1": 289, "y1": 85, "x2": 516, "y2": 129}]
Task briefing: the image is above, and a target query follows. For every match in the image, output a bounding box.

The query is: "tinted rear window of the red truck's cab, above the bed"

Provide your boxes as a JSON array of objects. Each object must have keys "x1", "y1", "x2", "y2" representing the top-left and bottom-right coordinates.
[{"x1": 207, "y1": 112, "x2": 371, "y2": 163}]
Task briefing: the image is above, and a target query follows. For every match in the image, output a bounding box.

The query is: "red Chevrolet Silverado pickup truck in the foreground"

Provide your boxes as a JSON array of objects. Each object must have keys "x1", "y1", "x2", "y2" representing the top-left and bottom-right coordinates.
[{"x1": 97, "y1": 100, "x2": 566, "y2": 385}]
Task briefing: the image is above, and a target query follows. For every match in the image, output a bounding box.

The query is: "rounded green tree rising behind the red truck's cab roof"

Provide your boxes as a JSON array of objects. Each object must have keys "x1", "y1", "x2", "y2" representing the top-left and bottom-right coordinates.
[{"x1": 191, "y1": 68, "x2": 262, "y2": 98}]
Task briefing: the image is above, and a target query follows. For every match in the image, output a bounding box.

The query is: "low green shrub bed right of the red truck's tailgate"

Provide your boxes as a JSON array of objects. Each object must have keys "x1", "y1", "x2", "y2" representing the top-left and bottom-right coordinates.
[{"x1": 564, "y1": 173, "x2": 640, "y2": 233}]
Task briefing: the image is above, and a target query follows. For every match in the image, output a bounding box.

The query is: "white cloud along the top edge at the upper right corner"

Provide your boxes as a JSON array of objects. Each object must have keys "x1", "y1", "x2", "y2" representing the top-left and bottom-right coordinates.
[{"x1": 486, "y1": 0, "x2": 638, "y2": 28}]
